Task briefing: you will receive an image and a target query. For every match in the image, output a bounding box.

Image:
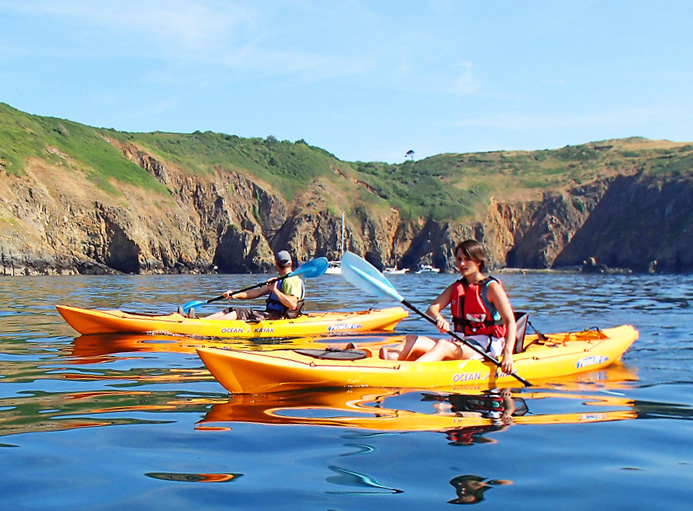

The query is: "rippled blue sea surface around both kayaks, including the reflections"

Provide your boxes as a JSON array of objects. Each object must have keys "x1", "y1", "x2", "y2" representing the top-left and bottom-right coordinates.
[{"x1": 0, "y1": 273, "x2": 693, "y2": 511}]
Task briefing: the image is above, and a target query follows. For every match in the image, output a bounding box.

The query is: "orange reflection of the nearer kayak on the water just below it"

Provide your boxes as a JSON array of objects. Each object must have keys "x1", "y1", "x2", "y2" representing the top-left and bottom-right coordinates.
[{"x1": 196, "y1": 369, "x2": 637, "y2": 438}]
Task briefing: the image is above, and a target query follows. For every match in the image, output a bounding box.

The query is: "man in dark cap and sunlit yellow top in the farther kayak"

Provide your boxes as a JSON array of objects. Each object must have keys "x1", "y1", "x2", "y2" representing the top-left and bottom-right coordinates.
[{"x1": 206, "y1": 250, "x2": 305, "y2": 321}]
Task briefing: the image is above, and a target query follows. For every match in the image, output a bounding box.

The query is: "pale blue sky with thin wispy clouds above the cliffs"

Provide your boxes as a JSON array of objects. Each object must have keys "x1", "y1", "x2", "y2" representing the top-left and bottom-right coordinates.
[{"x1": 0, "y1": 0, "x2": 693, "y2": 163}]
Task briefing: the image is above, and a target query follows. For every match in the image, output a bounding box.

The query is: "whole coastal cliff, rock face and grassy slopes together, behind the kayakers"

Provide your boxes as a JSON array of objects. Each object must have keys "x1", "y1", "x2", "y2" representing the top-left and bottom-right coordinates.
[{"x1": 0, "y1": 103, "x2": 693, "y2": 275}]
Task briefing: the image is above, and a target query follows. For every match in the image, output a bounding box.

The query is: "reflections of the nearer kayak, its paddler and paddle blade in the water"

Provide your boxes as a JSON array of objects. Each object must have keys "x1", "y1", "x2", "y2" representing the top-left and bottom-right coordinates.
[{"x1": 196, "y1": 380, "x2": 638, "y2": 504}]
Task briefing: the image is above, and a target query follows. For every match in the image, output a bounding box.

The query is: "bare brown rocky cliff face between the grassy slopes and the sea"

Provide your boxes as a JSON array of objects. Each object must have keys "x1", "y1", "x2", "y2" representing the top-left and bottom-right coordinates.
[{"x1": 0, "y1": 141, "x2": 693, "y2": 275}]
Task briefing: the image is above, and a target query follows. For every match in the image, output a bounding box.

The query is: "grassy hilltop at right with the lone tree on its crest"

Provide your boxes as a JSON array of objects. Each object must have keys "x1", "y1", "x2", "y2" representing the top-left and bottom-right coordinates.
[{"x1": 355, "y1": 138, "x2": 693, "y2": 221}]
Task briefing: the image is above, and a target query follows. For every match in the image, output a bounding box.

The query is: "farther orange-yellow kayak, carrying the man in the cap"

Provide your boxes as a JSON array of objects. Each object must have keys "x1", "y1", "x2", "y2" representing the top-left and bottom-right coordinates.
[{"x1": 56, "y1": 305, "x2": 408, "y2": 338}]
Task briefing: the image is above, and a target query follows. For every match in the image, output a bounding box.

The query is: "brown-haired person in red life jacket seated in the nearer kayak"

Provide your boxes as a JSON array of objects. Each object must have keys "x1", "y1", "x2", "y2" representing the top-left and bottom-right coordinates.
[{"x1": 380, "y1": 240, "x2": 517, "y2": 374}]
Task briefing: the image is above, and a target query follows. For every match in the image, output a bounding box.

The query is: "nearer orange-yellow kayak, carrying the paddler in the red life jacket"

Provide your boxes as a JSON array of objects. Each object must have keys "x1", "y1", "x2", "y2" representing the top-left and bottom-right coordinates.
[{"x1": 197, "y1": 325, "x2": 638, "y2": 393}]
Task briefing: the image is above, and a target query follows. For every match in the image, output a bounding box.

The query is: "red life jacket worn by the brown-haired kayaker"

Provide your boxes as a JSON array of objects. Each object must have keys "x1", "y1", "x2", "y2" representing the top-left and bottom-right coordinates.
[{"x1": 450, "y1": 277, "x2": 505, "y2": 339}]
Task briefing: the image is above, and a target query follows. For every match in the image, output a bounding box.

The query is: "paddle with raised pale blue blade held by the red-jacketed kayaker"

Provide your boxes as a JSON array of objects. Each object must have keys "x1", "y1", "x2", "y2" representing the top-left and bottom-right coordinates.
[{"x1": 342, "y1": 252, "x2": 532, "y2": 387}]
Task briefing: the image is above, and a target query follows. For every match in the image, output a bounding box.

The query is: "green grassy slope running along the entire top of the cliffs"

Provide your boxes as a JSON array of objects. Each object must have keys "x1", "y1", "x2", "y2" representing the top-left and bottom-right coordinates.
[{"x1": 0, "y1": 103, "x2": 693, "y2": 221}]
